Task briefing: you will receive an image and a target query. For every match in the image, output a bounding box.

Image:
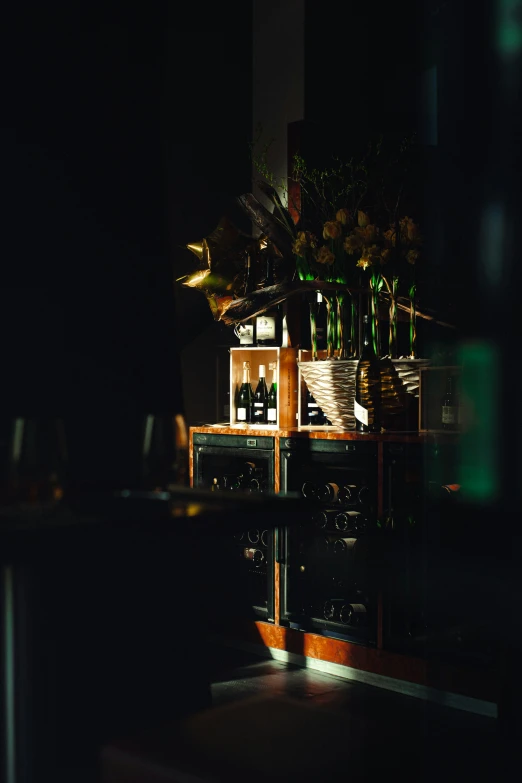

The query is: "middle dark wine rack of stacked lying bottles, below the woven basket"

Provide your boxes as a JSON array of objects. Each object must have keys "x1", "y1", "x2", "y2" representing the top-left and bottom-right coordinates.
[{"x1": 279, "y1": 438, "x2": 378, "y2": 644}]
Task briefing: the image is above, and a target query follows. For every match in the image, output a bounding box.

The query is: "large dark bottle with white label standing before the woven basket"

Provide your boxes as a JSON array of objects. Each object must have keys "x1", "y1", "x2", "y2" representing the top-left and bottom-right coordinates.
[{"x1": 354, "y1": 315, "x2": 381, "y2": 432}]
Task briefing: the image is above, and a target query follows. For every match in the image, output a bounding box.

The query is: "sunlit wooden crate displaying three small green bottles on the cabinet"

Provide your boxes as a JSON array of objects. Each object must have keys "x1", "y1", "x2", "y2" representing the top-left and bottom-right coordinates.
[{"x1": 230, "y1": 347, "x2": 298, "y2": 430}]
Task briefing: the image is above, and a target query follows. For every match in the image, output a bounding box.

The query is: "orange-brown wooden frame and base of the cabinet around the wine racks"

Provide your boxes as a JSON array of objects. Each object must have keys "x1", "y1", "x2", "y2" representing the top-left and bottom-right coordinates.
[{"x1": 190, "y1": 425, "x2": 499, "y2": 715}]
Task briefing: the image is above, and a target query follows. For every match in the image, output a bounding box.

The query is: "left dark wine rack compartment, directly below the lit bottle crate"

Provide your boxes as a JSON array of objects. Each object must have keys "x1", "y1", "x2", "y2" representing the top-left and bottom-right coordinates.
[{"x1": 189, "y1": 433, "x2": 274, "y2": 622}]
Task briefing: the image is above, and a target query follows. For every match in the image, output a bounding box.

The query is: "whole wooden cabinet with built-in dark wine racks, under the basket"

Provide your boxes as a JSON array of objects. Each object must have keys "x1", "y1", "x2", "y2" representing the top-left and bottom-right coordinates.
[{"x1": 190, "y1": 426, "x2": 499, "y2": 707}]
